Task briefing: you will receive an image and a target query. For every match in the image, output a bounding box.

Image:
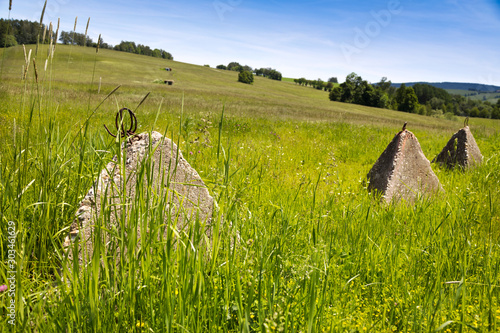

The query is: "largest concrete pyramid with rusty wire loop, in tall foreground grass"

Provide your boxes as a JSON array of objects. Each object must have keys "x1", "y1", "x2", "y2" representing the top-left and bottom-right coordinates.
[{"x1": 64, "y1": 132, "x2": 214, "y2": 266}]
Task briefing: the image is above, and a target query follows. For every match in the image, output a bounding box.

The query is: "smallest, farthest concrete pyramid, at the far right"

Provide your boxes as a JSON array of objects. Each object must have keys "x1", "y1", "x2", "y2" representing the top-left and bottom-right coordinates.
[{"x1": 432, "y1": 126, "x2": 483, "y2": 169}]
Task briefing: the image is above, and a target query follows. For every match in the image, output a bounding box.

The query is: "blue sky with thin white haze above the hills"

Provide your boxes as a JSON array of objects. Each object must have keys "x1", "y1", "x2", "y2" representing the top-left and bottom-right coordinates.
[{"x1": 0, "y1": 0, "x2": 500, "y2": 86}]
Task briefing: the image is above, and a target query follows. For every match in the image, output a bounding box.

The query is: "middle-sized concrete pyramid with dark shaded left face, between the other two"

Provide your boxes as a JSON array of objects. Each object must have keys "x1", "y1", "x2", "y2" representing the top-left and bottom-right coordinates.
[{"x1": 367, "y1": 123, "x2": 442, "y2": 202}]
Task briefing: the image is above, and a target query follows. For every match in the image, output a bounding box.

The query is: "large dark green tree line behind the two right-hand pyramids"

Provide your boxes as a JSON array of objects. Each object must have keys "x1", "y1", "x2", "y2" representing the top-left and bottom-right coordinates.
[{"x1": 329, "y1": 73, "x2": 500, "y2": 119}]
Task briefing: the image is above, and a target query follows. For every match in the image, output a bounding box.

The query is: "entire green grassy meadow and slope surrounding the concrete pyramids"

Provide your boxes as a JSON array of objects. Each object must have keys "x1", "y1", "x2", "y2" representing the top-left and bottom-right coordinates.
[{"x1": 0, "y1": 45, "x2": 500, "y2": 332}]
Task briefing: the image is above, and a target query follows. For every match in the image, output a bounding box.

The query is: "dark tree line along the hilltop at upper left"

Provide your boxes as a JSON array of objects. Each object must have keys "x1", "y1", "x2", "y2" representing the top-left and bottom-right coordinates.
[{"x1": 0, "y1": 19, "x2": 174, "y2": 60}]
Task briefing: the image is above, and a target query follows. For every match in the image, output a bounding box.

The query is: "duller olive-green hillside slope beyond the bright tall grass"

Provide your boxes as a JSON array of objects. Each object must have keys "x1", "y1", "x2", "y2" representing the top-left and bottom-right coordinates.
[{"x1": 0, "y1": 45, "x2": 495, "y2": 134}]
